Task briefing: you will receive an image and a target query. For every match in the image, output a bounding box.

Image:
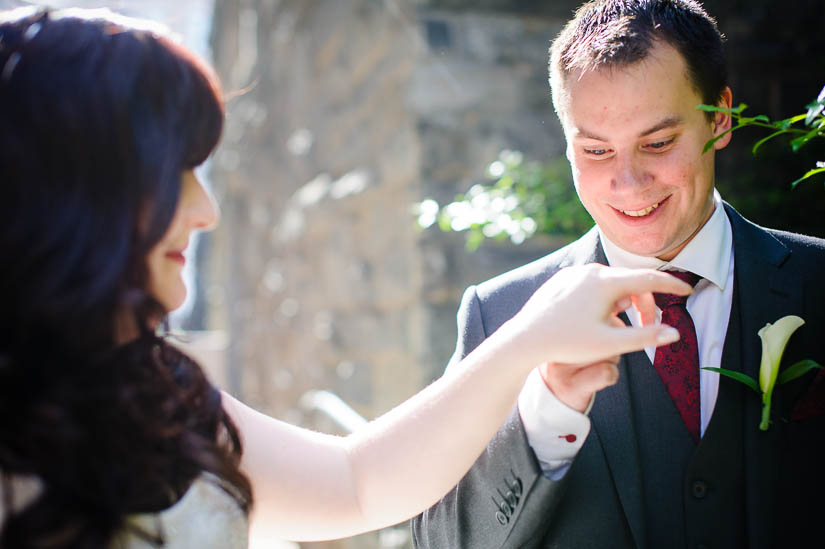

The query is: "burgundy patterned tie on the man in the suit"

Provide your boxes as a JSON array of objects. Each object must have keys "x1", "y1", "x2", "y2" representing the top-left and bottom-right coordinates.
[{"x1": 653, "y1": 271, "x2": 702, "y2": 443}]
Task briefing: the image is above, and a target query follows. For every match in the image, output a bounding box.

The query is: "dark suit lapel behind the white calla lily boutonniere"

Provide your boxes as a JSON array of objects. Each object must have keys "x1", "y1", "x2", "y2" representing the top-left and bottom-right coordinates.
[{"x1": 723, "y1": 204, "x2": 802, "y2": 548}]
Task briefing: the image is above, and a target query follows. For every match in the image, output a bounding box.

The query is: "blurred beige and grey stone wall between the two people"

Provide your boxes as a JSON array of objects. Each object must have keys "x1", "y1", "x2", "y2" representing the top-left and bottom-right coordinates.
[{"x1": 206, "y1": 0, "x2": 562, "y2": 422}]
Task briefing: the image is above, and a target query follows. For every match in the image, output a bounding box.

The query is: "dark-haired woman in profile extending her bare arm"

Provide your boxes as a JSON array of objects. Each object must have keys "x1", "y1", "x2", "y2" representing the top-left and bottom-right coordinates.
[{"x1": 0, "y1": 6, "x2": 690, "y2": 549}]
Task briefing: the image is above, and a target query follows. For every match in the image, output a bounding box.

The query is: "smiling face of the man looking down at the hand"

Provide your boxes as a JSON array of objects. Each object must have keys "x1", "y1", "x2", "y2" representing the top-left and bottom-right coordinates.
[{"x1": 560, "y1": 43, "x2": 731, "y2": 261}]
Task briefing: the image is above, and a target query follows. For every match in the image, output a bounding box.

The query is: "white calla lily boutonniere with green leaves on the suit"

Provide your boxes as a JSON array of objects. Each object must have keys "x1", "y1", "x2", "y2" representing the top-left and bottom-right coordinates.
[{"x1": 702, "y1": 315, "x2": 822, "y2": 431}]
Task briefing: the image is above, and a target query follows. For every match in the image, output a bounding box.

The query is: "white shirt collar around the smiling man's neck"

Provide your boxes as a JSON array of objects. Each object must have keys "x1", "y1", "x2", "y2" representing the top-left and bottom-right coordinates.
[{"x1": 599, "y1": 189, "x2": 733, "y2": 290}]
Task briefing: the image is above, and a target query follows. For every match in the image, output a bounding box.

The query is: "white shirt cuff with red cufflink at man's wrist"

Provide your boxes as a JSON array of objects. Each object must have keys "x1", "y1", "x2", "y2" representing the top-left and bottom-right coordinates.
[{"x1": 518, "y1": 368, "x2": 593, "y2": 480}]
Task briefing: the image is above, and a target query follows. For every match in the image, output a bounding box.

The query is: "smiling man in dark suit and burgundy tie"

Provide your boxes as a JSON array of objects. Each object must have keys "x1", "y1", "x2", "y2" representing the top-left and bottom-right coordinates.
[{"x1": 413, "y1": 0, "x2": 825, "y2": 549}]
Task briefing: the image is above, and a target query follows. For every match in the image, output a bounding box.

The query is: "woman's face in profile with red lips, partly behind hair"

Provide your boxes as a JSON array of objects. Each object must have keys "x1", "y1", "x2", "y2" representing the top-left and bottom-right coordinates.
[{"x1": 147, "y1": 170, "x2": 218, "y2": 311}]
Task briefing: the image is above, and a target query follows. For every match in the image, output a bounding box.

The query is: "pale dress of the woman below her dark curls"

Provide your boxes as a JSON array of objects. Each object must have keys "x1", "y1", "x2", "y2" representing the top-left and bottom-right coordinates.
[{"x1": 112, "y1": 473, "x2": 249, "y2": 549}]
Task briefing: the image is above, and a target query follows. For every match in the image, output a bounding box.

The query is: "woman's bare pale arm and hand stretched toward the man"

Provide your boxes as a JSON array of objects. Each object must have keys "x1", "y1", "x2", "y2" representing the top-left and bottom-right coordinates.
[{"x1": 224, "y1": 266, "x2": 690, "y2": 540}]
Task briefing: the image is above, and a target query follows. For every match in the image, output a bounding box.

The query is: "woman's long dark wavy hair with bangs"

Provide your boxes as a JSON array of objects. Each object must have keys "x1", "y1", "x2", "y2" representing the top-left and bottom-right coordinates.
[{"x1": 0, "y1": 11, "x2": 251, "y2": 549}]
